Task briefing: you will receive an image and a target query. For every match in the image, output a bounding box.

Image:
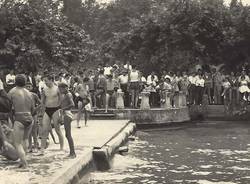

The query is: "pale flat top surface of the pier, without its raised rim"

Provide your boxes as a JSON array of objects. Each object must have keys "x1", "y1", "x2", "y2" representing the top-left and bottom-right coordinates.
[{"x1": 0, "y1": 120, "x2": 128, "y2": 184}]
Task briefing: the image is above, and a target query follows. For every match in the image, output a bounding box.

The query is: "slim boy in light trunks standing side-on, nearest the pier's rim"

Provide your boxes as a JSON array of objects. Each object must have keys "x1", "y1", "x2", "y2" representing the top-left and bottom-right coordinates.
[{"x1": 58, "y1": 83, "x2": 76, "y2": 158}]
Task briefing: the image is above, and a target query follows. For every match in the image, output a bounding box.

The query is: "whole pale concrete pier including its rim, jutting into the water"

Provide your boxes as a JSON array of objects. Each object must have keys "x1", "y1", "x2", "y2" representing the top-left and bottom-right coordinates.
[{"x1": 0, "y1": 120, "x2": 135, "y2": 184}]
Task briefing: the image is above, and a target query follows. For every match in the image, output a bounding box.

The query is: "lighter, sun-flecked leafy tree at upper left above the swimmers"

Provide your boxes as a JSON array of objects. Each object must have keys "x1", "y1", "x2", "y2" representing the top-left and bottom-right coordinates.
[{"x1": 0, "y1": 0, "x2": 96, "y2": 71}]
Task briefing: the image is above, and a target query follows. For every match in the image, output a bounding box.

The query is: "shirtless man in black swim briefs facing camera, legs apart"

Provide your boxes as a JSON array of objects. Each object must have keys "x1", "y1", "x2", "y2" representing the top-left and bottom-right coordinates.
[{"x1": 39, "y1": 76, "x2": 64, "y2": 155}]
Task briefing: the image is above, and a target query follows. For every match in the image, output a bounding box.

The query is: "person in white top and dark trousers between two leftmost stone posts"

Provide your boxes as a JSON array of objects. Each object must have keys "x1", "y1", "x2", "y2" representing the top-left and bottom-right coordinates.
[{"x1": 118, "y1": 70, "x2": 129, "y2": 107}]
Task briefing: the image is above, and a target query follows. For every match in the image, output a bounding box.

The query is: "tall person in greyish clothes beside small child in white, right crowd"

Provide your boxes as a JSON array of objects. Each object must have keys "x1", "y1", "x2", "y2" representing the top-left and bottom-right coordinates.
[{"x1": 213, "y1": 68, "x2": 223, "y2": 105}]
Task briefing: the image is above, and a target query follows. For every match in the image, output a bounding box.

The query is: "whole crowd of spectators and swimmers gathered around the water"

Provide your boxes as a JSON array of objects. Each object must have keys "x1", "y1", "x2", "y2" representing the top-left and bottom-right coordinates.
[{"x1": 0, "y1": 62, "x2": 250, "y2": 167}]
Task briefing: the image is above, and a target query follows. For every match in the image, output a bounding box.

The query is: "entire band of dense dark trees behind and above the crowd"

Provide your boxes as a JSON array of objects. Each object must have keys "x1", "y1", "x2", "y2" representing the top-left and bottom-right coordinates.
[{"x1": 0, "y1": 0, "x2": 250, "y2": 72}]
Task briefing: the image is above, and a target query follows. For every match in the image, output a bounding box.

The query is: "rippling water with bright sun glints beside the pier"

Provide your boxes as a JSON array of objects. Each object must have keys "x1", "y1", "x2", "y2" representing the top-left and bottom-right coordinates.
[{"x1": 81, "y1": 123, "x2": 250, "y2": 184}]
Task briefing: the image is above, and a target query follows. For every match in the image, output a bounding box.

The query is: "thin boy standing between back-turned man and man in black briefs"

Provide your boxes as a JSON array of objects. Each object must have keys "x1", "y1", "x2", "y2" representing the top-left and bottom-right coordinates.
[{"x1": 26, "y1": 82, "x2": 41, "y2": 152}]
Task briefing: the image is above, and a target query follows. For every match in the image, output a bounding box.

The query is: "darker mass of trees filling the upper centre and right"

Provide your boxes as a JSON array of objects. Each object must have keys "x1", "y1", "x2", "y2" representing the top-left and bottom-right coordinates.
[{"x1": 75, "y1": 0, "x2": 250, "y2": 72}]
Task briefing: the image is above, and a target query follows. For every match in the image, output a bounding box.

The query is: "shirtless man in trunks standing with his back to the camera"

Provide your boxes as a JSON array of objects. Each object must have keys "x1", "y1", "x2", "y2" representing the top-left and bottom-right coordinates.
[{"x1": 8, "y1": 75, "x2": 34, "y2": 168}]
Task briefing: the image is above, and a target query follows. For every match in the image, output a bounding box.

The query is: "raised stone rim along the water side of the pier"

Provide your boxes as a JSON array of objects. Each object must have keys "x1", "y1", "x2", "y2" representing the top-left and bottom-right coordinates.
[{"x1": 49, "y1": 122, "x2": 136, "y2": 184}]
